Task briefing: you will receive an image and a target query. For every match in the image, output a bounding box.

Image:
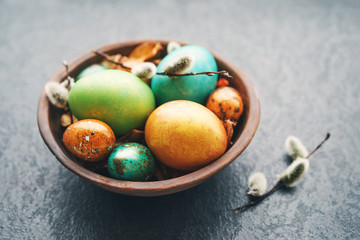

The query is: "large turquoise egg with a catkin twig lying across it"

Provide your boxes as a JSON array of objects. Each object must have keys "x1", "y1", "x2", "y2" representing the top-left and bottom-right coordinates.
[{"x1": 151, "y1": 45, "x2": 218, "y2": 106}]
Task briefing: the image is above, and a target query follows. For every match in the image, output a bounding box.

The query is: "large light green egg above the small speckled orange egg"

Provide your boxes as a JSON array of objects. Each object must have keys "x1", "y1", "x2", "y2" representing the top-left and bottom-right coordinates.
[{"x1": 69, "y1": 70, "x2": 155, "y2": 137}]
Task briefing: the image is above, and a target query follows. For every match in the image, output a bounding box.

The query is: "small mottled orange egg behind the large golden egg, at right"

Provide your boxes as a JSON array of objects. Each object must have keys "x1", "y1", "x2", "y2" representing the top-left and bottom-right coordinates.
[{"x1": 206, "y1": 87, "x2": 244, "y2": 122}]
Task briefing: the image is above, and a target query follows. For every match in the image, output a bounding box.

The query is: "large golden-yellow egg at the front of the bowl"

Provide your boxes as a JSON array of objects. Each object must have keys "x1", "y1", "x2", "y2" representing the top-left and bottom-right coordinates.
[{"x1": 145, "y1": 100, "x2": 227, "y2": 170}]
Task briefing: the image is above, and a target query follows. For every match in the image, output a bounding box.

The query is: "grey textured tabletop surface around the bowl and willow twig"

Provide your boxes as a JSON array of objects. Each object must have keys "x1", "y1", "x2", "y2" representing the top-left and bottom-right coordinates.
[{"x1": 0, "y1": 0, "x2": 360, "y2": 239}]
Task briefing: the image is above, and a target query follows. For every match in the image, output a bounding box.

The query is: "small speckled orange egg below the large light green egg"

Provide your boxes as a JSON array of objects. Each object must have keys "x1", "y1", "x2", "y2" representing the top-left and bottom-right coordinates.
[{"x1": 62, "y1": 119, "x2": 116, "y2": 162}]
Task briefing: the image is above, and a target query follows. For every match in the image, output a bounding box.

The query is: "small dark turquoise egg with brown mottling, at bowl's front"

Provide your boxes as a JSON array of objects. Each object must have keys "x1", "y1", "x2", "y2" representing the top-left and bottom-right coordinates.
[{"x1": 107, "y1": 143, "x2": 155, "y2": 181}]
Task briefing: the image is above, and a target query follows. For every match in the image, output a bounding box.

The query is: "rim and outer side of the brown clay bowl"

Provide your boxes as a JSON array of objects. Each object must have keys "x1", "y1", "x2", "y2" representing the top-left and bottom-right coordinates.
[{"x1": 37, "y1": 39, "x2": 260, "y2": 196}]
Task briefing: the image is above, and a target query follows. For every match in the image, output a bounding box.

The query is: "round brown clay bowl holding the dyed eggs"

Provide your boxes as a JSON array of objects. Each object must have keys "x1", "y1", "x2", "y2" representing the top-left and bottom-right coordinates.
[{"x1": 37, "y1": 40, "x2": 260, "y2": 196}]
